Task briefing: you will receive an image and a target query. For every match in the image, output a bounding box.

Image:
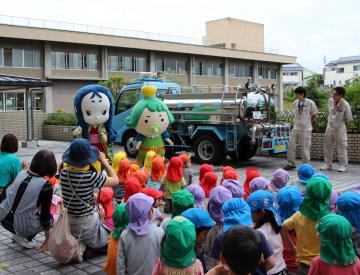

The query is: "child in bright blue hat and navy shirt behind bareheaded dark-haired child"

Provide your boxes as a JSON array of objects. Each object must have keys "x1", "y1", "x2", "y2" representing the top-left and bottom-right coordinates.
[{"x1": 210, "y1": 198, "x2": 275, "y2": 274}]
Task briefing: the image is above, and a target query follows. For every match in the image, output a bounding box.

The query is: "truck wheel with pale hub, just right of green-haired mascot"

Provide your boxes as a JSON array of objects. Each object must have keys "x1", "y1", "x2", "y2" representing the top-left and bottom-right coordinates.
[{"x1": 194, "y1": 135, "x2": 226, "y2": 164}]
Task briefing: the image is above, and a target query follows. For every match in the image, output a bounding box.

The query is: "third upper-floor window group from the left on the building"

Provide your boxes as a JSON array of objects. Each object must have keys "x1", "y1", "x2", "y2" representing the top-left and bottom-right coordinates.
[{"x1": 108, "y1": 55, "x2": 147, "y2": 72}]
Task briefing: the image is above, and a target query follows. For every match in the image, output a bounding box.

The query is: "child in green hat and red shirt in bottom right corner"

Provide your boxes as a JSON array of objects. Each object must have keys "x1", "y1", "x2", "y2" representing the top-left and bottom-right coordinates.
[{"x1": 309, "y1": 214, "x2": 360, "y2": 275}]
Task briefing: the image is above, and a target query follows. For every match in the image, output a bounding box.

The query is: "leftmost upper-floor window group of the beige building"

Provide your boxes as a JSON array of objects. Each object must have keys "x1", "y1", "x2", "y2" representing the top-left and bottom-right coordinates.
[{"x1": 0, "y1": 48, "x2": 41, "y2": 68}]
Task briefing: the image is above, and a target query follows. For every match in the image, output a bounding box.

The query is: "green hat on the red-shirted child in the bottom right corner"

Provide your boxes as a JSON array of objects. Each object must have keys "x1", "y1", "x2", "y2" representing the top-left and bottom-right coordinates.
[{"x1": 317, "y1": 214, "x2": 357, "y2": 266}]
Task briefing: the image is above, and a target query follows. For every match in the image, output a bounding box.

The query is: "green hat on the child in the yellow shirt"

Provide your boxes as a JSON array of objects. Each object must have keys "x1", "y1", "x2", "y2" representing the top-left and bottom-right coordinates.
[{"x1": 300, "y1": 178, "x2": 332, "y2": 221}]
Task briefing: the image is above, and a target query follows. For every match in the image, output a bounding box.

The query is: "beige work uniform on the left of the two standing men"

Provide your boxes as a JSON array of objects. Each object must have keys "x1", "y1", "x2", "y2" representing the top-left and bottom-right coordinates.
[{"x1": 287, "y1": 98, "x2": 317, "y2": 166}]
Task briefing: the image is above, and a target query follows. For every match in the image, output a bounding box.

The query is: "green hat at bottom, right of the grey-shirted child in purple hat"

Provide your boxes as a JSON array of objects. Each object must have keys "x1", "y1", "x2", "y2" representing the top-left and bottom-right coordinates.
[{"x1": 160, "y1": 216, "x2": 196, "y2": 268}]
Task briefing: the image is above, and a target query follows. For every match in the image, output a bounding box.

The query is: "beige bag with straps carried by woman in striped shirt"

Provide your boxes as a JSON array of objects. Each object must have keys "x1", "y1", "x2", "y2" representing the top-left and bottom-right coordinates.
[{"x1": 49, "y1": 171, "x2": 90, "y2": 264}]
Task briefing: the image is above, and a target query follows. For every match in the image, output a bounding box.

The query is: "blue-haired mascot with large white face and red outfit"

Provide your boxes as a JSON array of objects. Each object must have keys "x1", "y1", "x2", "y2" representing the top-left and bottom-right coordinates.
[{"x1": 73, "y1": 85, "x2": 116, "y2": 160}]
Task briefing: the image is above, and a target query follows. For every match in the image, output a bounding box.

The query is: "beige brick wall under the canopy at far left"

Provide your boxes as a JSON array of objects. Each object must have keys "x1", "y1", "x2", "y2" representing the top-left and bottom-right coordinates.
[{"x1": 0, "y1": 111, "x2": 47, "y2": 141}]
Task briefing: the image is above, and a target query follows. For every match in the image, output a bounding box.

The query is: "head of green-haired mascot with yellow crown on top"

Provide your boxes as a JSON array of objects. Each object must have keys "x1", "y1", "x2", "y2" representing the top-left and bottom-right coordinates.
[{"x1": 125, "y1": 86, "x2": 174, "y2": 137}]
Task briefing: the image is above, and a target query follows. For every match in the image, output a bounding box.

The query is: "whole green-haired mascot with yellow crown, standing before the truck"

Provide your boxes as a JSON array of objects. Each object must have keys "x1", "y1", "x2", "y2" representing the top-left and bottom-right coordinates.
[{"x1": 125, "y1": 86, "x2": 174, "y2": 165}]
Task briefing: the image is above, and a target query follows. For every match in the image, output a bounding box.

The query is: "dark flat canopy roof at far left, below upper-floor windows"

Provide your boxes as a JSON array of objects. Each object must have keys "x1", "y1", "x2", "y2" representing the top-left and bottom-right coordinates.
[{"x1": 0, "y1": 74, "x2": 53, "y2": 91}]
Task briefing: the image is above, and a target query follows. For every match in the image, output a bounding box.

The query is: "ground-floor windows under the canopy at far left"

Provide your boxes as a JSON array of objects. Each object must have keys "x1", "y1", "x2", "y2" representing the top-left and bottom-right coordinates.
[{"x1": 0, "y1": 92, "x2": 44, "y2": 111}]
